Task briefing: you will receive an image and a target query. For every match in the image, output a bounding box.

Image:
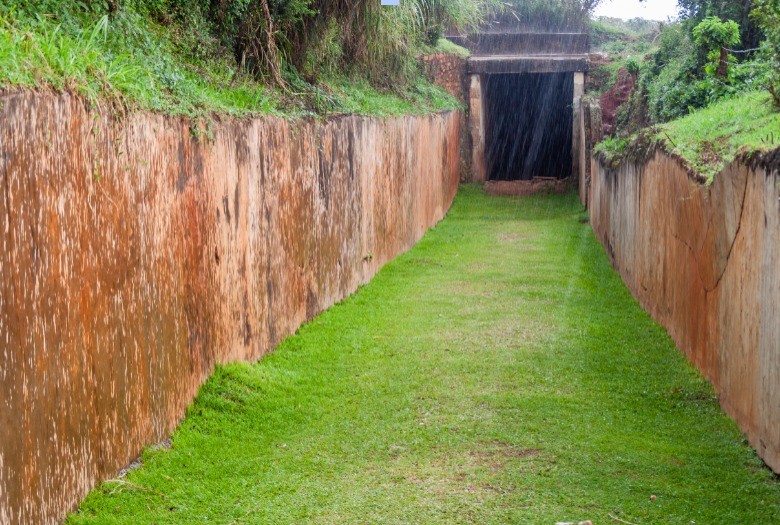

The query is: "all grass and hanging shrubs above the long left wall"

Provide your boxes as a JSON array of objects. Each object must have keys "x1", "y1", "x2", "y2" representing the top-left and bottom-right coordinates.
[{"x1": 0, "y1": 0, "x2": 492, "y2": 117}]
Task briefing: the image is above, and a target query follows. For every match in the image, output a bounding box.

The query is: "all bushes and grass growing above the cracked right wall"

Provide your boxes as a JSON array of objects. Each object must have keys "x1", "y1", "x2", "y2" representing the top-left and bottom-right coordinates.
[{"x1": 595, "y1": 0, "x2": 780, "y2": 181}]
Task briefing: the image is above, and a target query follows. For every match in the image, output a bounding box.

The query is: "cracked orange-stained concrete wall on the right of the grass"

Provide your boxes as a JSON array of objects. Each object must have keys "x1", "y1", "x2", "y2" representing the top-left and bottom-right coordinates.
[{"x1": 590, "y1": 152, "x2": 780, "y2": 472}]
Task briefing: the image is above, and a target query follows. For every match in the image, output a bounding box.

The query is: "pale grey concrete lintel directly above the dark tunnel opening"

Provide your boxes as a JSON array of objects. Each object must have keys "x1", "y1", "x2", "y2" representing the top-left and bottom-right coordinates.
[{"x1": 468, "y1": 55, "x2": 588, "y2": 75}]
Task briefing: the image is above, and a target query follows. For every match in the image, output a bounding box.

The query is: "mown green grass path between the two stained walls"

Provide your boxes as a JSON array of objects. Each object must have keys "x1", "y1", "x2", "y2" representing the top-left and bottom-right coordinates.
[{"x1": 68, "y1": 186, "x2": 780, "y2": 525}]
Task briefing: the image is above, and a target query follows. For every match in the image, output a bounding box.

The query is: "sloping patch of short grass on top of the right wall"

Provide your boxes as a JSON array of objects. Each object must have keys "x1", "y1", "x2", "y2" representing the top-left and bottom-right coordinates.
[{"x1": 595, "y1": 91, "x2": 780, "y2": 182}]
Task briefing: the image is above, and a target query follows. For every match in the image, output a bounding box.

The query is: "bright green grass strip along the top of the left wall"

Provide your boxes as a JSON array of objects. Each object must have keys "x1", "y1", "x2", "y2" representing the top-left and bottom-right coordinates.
[{"x1": 0, "y1": 6, "x2": 461, "y2": 118}]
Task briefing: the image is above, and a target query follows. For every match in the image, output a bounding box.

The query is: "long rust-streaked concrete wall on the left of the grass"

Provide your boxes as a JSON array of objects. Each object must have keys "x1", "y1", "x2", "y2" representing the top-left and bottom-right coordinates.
[{"x1": 0, "y1": 92, "x2": 460, "y2": 525}]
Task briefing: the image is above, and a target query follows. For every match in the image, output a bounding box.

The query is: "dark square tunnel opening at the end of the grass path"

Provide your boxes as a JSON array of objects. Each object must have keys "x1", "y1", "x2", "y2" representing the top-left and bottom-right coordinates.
[{"x1": 485, "y1": 73, "x2": 574, "y2": 180}]
